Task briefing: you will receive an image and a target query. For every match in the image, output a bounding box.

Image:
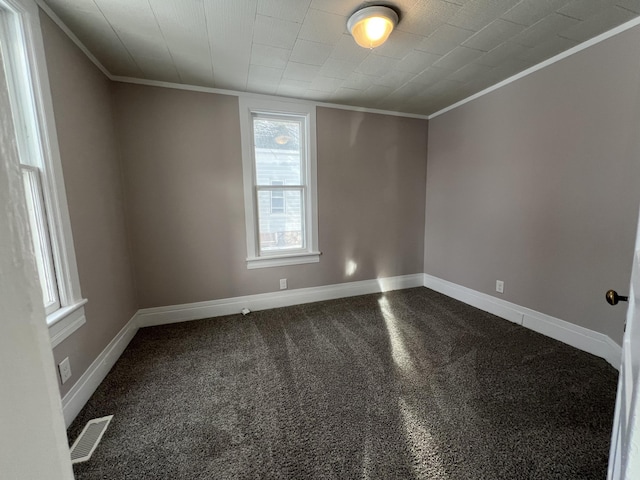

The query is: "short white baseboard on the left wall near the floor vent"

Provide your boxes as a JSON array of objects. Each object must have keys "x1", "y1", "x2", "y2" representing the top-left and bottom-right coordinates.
[{"x1": 62, "y1": 314, "x2": 138, "y2": 428}]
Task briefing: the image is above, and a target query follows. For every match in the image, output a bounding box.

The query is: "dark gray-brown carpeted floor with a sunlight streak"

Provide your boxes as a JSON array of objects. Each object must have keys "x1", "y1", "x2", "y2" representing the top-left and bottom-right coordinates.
[{"x1": 68, "y1": 288, "x2": 617, "y2": 480}]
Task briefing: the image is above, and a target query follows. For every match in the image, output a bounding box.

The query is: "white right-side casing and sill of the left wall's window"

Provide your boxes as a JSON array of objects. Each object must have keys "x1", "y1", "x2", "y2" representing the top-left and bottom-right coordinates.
[{"x1": 0, "y1": 0, "x2": 87, "y2": 347}]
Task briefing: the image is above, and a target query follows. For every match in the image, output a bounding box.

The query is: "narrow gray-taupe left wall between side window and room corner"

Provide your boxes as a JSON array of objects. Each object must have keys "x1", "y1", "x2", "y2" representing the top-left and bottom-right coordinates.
[{"x1": 40, "y1": 14, "x2": 137, "y2": 395}]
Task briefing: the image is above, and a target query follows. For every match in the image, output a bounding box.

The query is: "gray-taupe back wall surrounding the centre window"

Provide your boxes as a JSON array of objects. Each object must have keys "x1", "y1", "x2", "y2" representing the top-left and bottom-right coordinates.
[{"x1": 114, "y1": 84, "x2": 427, "y2": 308}]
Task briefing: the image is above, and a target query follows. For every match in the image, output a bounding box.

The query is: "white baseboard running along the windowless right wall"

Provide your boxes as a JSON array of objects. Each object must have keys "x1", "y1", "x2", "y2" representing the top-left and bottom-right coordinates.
[{"x1": 424, "y1": 273, "x2": 622, "y2": 369}]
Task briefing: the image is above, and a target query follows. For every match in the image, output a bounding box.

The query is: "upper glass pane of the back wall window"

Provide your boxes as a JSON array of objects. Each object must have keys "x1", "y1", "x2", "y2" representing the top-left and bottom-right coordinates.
[{"x1": 253, "y1": 117, "x2": 303, "y2": 185}]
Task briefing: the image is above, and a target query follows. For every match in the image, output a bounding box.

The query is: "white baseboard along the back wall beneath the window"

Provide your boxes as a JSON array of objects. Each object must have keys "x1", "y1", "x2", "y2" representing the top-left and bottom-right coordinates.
[{"x1": 137, "y1": 273, "x2": 423, "y2": 327}]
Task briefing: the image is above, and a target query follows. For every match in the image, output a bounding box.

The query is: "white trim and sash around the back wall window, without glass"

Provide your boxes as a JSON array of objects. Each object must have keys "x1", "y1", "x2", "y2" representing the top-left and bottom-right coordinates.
[{"x1": 238, "y1": 97, "x2": 321, "y2": 269}]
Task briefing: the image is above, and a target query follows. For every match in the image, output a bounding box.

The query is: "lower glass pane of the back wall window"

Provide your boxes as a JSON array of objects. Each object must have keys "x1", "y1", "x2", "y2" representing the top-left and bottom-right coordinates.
[{"x1": 258, "y1": 188, "x2": 305, "y2": 253}]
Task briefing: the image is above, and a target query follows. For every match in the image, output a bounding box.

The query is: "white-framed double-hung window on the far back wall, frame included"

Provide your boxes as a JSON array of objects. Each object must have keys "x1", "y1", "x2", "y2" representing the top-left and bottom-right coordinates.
[{"x1": 240, "y1": 97, "x2": 320, "y2": 268}]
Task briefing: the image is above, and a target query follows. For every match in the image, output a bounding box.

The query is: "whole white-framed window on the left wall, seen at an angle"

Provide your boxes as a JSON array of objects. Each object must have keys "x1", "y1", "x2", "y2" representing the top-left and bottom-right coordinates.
[{"x1": 0, "y1": 0, "x2": 86, "y2": 347}]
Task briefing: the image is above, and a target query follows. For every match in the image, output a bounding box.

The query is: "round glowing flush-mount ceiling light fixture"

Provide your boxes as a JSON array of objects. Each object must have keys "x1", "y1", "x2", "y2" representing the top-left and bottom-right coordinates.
[{"x1": 347, "y1": 6, "x2": 398, "y2": 48}]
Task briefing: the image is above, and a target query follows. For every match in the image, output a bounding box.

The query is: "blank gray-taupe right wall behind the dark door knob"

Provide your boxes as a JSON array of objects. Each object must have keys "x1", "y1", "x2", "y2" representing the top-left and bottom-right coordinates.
[{"x1": 425, "y1": 27, "x2": 640, "y2": 342}]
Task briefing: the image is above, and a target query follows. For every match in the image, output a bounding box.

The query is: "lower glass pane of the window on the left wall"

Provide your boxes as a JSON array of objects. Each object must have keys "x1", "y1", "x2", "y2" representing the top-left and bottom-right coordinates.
[{"x1": 22, "y1": 167, "x2": 60, "y2": 313}]
